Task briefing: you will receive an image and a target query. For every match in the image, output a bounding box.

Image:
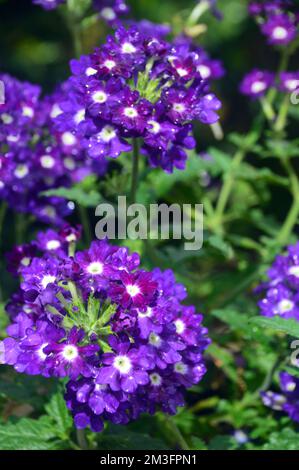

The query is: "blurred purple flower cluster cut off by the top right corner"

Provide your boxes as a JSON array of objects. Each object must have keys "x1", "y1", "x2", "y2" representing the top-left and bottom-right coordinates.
[{"x1": 249, "y1": 0, "x2": 299, "y2": 45}]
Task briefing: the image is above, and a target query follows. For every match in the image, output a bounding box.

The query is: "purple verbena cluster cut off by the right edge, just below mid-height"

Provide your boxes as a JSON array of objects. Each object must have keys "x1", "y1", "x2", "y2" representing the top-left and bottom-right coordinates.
[{"x1": 257, "y1": 243, "x2": 299, "y2": 320}]
